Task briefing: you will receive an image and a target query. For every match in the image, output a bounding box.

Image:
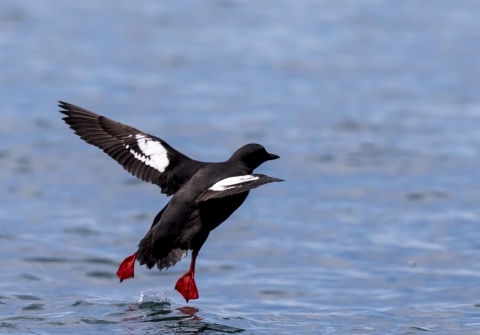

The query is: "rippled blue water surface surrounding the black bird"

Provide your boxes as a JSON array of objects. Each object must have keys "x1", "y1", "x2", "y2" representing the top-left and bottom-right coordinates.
[{"x1": 0, "y1": 0, "x2": 480, "y2": 334}]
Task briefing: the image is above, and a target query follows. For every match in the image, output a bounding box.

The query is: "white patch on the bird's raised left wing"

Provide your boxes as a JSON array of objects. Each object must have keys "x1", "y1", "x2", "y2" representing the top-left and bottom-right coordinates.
[{"x1": 124, "y1": 134, "x2": 170, "y2": 172}]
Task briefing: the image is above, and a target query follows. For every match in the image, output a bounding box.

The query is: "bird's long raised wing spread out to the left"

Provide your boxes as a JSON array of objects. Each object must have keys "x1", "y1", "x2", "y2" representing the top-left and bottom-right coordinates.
[{"x1": 59, "y1": 101, "x2": 205, "y2": 195}]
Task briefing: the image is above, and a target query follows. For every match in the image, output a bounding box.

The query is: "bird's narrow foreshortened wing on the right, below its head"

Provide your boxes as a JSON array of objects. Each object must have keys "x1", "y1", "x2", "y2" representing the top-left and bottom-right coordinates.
[{"x1": 197, "y1": 174, "x2": 284, "y2": 202}]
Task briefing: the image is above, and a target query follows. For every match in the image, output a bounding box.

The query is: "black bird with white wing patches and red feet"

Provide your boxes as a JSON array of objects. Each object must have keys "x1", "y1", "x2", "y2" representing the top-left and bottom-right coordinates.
[{"x1": 58, "y1": 101, "x2": 284, "y2": 303}]
